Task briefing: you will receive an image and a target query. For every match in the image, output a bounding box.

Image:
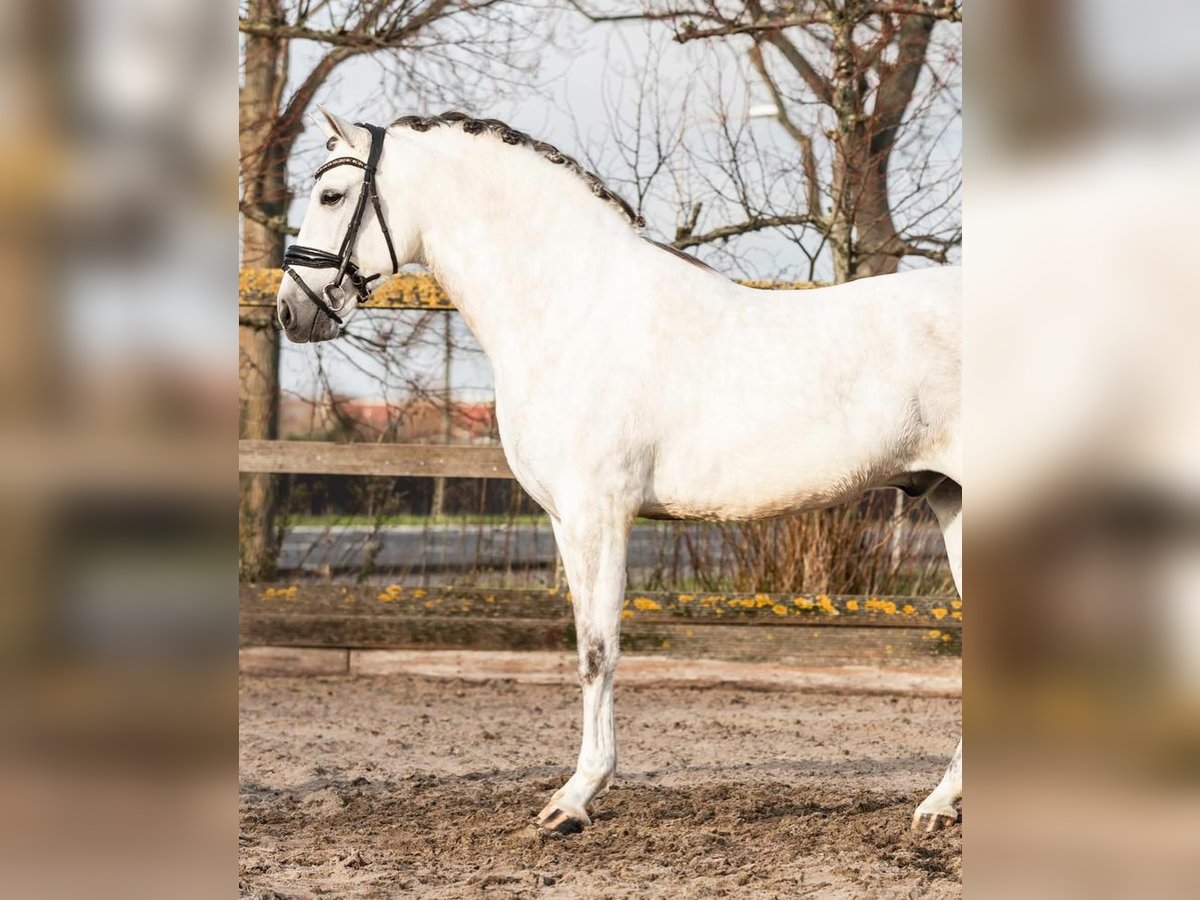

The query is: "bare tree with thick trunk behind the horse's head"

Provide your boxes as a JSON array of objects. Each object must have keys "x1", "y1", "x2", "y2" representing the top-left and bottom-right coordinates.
[{"x1": 238, "y1": 0, "x2": 552, "y2": 578}]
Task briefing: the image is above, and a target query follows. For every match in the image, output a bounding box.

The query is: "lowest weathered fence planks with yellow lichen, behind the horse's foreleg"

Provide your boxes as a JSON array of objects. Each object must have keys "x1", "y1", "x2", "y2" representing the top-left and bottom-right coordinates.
[{"x1": 240, "y1": 583, "x2": 962, "y2": 665}]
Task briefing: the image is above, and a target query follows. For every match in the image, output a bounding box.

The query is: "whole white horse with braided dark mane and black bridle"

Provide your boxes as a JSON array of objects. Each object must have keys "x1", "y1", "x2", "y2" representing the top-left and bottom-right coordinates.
[{"x1": 278, "y1": 110, "x2": 962, "y2": 833}]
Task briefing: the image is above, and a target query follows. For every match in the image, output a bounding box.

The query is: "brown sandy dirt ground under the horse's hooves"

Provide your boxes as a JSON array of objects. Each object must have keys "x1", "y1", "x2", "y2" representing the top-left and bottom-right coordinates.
[{"x1": 240, "y1": 674, "x2": 962, "y2": 898}]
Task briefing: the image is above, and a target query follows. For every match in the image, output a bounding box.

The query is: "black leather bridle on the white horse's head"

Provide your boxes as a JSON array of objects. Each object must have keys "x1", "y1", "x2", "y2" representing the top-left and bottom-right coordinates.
[{"x1": 283, "y1": 122, "x2": 400, "y2": 325}]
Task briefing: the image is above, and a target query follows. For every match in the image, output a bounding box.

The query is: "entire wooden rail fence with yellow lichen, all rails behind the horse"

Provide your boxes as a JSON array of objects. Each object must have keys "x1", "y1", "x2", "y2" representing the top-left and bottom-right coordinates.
[{"x1": 239, "y1": 270, "x2": 962, "y2": 665}]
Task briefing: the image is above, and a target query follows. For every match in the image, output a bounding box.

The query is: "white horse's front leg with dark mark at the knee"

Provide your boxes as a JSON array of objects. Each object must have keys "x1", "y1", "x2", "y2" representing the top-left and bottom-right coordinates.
[{"x1": 539, "y1": 508, "x2": 632, "y2": 834}]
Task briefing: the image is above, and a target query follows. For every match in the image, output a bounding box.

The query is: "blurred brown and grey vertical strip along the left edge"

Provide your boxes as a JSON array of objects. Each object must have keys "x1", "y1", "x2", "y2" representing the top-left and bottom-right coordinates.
[{"x1": 0, "y1": 0, "x2": 231, "y2": 898}]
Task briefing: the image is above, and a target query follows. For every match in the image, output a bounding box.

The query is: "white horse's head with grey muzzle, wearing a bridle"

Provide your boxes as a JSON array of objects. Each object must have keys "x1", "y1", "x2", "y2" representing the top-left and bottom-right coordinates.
[{"x1": 276, "y1": 108, "x2": 420, "y2": 343}]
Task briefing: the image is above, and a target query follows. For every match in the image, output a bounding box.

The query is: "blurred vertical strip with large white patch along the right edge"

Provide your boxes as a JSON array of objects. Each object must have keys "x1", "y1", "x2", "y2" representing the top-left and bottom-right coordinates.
[{"x1": 964, "y1": 0, "x2": 1200, "y2": 896}]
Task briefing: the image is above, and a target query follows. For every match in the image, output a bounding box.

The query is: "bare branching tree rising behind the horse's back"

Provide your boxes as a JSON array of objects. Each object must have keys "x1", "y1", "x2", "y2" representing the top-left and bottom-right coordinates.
[{"x1": 568, "y1": 0, "x2": 961, "y2": 282}]
